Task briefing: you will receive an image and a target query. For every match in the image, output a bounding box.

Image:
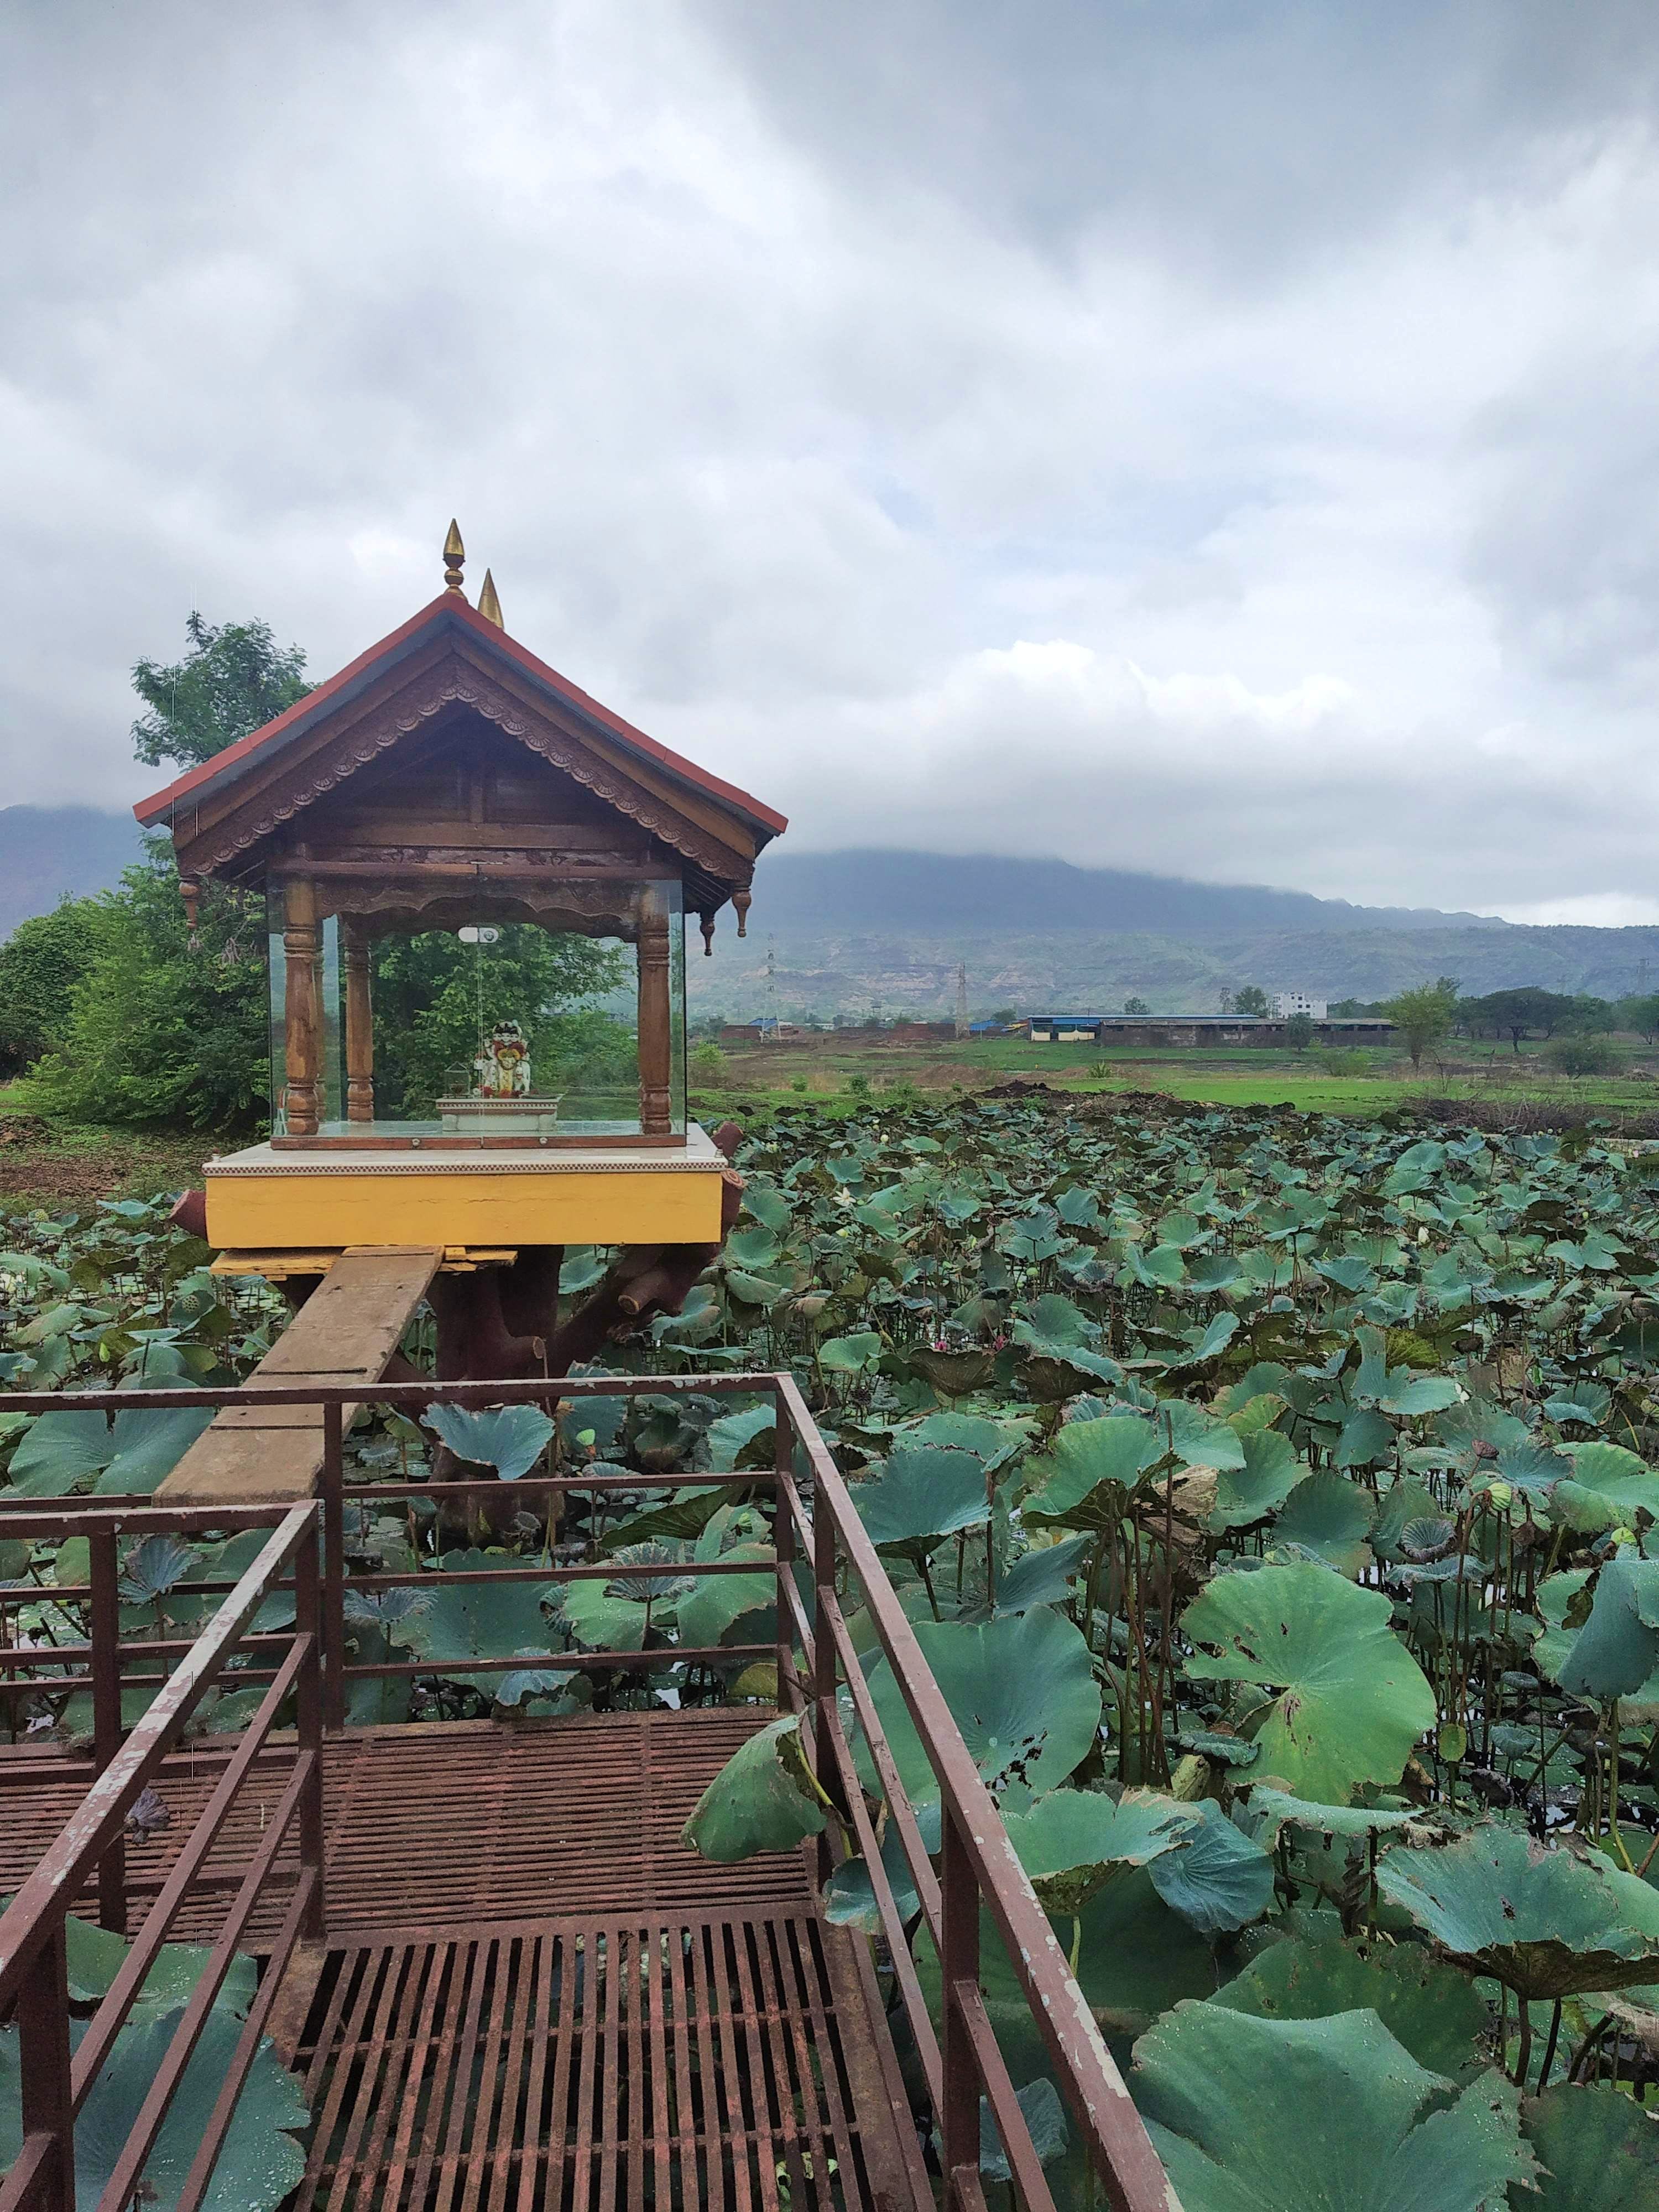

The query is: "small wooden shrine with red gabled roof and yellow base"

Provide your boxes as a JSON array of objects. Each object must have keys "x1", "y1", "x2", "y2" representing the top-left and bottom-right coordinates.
[{"x1": 135, "y1": 524, "x2": 785, "y2": 1254}]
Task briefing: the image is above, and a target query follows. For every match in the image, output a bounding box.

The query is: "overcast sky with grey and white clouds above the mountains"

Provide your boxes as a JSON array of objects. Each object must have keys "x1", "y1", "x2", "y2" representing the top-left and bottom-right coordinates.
[{"x1": 0, "y1": 0, "x2": 1659, "y2": 922}]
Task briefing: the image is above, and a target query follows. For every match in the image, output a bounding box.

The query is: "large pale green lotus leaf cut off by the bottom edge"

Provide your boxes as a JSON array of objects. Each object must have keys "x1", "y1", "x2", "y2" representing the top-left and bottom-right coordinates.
[{"x1": 1130, "y1": 2004, "x2": 1535, "y2": 2212}]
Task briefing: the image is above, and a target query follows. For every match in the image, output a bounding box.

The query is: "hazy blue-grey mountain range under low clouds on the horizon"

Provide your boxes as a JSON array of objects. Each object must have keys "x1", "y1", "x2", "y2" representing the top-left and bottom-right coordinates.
[{"x1": 0, "y1": 805, "x2": 1659, "y2": 1020}]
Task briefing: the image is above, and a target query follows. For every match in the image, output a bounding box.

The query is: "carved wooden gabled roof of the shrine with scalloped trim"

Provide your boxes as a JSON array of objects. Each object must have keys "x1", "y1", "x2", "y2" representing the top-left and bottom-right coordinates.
[{"x1": 133, "y1": 591, "x2": 785, "y2": 914}]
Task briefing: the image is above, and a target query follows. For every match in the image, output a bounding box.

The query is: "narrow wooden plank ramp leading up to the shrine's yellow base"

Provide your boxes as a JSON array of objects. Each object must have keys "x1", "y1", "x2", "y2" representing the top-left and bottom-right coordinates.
[{"x1": 155, "y1": 1245, "x2": 442, "y2": 1506}]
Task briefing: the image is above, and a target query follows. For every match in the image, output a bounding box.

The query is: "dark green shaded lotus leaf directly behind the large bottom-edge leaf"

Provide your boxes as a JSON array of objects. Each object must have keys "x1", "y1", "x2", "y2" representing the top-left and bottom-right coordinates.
[{"x1": 1210, "y1": 1931, "x2": 1491, "y2": 2081}]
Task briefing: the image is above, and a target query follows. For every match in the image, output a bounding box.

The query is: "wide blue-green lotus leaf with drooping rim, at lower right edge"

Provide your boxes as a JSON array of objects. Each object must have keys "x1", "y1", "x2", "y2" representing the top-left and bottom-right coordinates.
[{"x1": 1376, "y1": 1825, "x2": 1659, "y2": 2000}]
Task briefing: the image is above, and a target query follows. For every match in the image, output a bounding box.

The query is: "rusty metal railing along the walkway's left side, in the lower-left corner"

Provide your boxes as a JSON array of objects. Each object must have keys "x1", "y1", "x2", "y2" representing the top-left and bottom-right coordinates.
[{"x1": 0, "y1": 1502, "x2": 323, "y2": 2212}]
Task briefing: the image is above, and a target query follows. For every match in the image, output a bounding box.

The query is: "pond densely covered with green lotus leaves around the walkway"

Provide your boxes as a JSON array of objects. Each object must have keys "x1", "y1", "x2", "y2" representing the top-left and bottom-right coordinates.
[{"x1": 0, "y1": 1099, "x2": 1659, "y2": 2212}]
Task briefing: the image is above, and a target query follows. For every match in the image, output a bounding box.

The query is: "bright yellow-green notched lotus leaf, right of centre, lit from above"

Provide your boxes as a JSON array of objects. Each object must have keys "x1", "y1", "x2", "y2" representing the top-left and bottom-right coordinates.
[{"x1": 1181, "y1": 1564, "x2": 1436, "y2": 1805}]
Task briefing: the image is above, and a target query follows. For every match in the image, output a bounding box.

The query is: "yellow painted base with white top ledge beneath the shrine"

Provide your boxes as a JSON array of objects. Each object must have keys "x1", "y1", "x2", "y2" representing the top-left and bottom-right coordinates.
[{"x1": 206, "y1": 1130, "x2": 726, "y2": 1252}]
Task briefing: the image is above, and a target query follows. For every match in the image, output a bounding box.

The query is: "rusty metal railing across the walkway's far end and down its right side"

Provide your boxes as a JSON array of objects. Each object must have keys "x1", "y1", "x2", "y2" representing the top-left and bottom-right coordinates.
[{"x1": 0, "y1": 1374, "x2": 1179, "y2": 2212}]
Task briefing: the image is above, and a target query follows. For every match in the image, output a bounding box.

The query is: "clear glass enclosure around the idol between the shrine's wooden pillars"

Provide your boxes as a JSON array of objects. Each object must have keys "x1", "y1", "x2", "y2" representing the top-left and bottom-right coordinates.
[{"x1": 270, "y1": 880, "x2": 686, "y2": 1148}]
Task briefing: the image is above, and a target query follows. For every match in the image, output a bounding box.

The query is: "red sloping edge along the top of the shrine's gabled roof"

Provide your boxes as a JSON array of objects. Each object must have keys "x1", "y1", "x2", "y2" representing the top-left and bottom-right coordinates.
[{"x1": 133, "y1": 591, "x2": 790, "y2": 845}]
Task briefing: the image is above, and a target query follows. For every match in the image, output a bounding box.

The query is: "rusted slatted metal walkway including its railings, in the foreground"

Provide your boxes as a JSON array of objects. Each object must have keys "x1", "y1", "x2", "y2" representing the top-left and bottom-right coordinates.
[{"x1": 0, "y1": 1376, "x2": 1175, "y2": 2212}]
